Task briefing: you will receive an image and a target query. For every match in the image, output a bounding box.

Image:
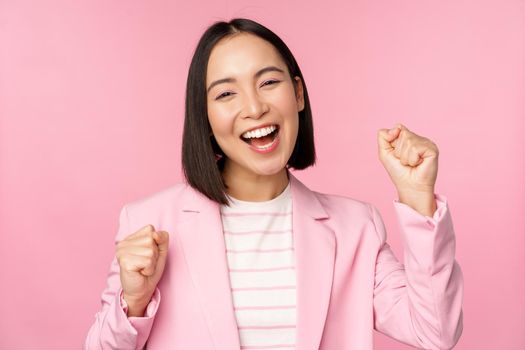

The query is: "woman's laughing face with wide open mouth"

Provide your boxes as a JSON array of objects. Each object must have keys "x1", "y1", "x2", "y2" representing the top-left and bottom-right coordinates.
[{"x1": 206, "y1": 33, "x2": 304, "y2": 179}]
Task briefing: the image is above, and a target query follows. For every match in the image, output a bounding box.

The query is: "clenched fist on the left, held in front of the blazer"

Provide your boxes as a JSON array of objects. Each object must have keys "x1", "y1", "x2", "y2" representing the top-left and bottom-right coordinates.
[{"x1": 115, "y1": 225, "x2": 169, "y2": 316}]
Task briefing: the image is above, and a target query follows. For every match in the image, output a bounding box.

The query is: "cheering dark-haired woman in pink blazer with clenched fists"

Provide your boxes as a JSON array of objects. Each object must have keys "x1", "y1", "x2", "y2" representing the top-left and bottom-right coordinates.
[{"x1": 84, "y1": 19, "x2": 463, "y2": 350}]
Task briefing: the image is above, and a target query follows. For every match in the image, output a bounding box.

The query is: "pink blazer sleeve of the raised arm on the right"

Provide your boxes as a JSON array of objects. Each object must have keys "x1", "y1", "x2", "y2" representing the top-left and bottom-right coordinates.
[{"x1": 370, "y1": 194, "x2": 463, "y2": 350}]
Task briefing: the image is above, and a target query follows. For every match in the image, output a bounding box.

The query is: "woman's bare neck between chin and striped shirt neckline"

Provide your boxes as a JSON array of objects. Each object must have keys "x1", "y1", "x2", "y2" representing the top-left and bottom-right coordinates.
[{"x1": 222, "y1": 164, "x2": 289, "y2": 202}]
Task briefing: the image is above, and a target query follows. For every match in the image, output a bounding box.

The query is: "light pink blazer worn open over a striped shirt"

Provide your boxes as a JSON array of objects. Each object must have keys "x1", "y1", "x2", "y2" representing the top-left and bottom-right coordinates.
[{"x1": 83, "y1": 172, "x2": 463, "y2": 350}]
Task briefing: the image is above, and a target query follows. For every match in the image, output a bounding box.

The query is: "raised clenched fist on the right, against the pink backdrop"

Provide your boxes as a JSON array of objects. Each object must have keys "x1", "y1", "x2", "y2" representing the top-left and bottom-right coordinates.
[{"x1": 377, "y1": 124, "x2": 439, "y2": 215}]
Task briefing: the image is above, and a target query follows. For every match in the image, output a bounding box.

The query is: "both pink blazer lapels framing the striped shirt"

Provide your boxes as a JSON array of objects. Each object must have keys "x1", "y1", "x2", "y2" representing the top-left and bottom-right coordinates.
[{"x1": 174, "y1": 172, "x2": 336, "y2": 350}]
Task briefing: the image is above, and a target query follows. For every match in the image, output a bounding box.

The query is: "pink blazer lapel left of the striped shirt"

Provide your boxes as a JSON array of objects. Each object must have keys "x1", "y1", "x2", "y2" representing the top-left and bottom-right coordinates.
[{"x1": 175, "y1": 185, "x2": 240, "y2": 350}]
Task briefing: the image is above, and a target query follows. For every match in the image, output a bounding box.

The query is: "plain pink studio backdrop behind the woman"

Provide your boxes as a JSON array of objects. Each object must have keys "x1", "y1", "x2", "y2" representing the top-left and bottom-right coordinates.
[{"x1": 0, "y1": 0, "x2": 525, "y2": 350}]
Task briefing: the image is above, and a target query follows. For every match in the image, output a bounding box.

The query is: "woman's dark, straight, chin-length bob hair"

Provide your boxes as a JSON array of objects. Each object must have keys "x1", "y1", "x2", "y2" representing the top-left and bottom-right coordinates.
[{"x1": 182, "y1": 18, "x2": 315, "y2": 205}]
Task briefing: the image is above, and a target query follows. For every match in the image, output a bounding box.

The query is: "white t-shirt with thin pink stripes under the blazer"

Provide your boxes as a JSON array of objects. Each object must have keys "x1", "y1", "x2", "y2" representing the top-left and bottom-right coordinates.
[{"x1": 221, "y1": 182, "x2": 296, "y2": 350}]
